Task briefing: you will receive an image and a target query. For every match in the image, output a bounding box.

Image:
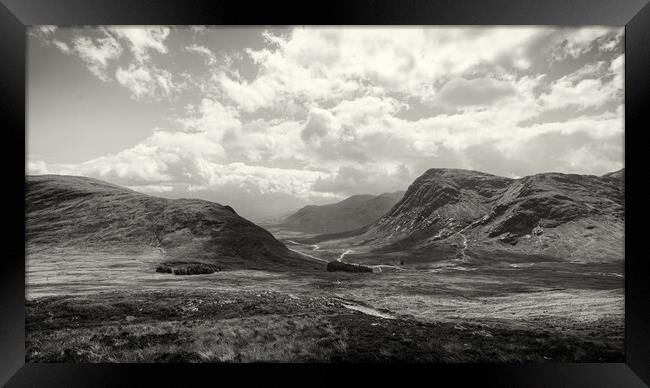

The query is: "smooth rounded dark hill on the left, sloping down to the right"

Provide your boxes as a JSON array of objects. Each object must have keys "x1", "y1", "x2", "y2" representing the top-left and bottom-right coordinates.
[{"x1": 25, "y1": 175, "x2": 322, "y2": 270}]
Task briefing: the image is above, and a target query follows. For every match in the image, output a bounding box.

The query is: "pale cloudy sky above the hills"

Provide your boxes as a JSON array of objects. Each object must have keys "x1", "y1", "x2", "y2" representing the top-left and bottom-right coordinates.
[{"x1": 26, "y1": 26, "x2": 624, "y2": 221}]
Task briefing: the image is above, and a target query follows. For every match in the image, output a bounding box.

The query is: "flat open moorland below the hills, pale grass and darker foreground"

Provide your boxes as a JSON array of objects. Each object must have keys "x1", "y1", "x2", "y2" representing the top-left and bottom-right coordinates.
[{"x1": 26, "y1": 233, "x2": 624, "y2": 362}]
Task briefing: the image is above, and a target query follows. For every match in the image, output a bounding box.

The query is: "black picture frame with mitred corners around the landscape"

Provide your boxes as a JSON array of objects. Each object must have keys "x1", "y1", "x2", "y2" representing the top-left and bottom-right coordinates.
[{"x1": 0, "y1": 0, "x2": 650, "y2": 387}]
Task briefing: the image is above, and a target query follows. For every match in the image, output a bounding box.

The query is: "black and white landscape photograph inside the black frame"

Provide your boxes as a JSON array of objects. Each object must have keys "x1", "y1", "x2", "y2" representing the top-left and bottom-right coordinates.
[{"x1": 25, "y1": 25, "x2": 632, "y2": 363}]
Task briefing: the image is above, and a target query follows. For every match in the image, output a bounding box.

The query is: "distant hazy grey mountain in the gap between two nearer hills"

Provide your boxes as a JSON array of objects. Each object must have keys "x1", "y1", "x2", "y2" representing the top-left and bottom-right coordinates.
[{"x1": 283, "y1": 191, "x2": 404, "y2": 233}]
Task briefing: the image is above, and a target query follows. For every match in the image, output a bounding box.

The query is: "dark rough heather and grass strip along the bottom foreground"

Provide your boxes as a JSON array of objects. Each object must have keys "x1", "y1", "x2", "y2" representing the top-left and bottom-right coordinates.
[{"x1": 26, "y1": 289, "x2": 623, "y2": 362}]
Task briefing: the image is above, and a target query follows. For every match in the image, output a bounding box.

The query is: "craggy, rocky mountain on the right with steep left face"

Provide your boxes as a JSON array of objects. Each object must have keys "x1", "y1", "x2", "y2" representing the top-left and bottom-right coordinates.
[{"x1": 356, "y1": 169, "x2": 625, "y2": 262}]
